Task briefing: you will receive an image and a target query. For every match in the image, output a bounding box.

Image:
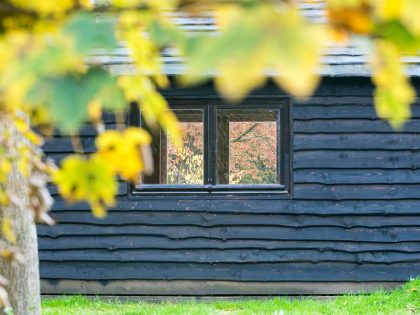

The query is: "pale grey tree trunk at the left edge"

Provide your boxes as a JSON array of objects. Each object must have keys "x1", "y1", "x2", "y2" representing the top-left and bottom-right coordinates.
[{"x1": 0, "y1": 114, "x2": 41, "y2": 315}]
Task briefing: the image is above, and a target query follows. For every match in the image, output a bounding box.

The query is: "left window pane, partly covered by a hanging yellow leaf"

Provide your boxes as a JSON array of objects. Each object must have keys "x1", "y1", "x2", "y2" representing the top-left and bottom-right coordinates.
[{"x1": 144, "y1": 109, "x2": 204, "y2": 185}]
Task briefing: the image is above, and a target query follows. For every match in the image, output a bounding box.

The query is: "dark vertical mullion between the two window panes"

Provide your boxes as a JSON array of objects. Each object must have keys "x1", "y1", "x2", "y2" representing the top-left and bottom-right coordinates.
[{"x1": 204, "y1": 104, "x2": 216, "y2": 185}]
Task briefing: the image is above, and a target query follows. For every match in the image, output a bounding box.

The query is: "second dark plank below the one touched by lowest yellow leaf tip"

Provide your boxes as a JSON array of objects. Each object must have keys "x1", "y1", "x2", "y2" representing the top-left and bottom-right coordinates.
[{"x1": 39, "y1": 235, "x2": 420, "y2": 253}]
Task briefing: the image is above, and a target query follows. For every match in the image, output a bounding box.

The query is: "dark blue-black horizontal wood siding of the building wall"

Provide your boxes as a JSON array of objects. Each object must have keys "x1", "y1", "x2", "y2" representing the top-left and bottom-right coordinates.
[{"x1": 38, "y1": 78, "x2": 420, "y2": 295}]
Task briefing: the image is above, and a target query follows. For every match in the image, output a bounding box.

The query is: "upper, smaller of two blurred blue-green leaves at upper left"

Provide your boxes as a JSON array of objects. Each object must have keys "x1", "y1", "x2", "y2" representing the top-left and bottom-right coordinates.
[{"x1": 63, "y1": 12, "x2": 117, "y2": 54}]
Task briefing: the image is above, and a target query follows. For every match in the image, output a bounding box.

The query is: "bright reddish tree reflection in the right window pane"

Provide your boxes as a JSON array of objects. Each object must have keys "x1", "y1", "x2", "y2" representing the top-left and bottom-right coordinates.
[{"x1": 229, "y1": 122, "x2": 277, "y2": 184}]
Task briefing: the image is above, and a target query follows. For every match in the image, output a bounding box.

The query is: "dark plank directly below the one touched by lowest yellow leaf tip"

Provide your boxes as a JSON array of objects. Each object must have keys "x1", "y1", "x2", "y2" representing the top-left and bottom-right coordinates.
[{"x1": 38, "y1": 224, "x2": 420, "y2": 243}]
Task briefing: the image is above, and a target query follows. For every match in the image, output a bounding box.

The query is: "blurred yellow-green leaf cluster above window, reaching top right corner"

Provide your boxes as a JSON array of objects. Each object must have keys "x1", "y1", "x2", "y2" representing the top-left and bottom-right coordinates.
[{"x1": 184, "y1": 0, "x2": 420, "y2": 128}]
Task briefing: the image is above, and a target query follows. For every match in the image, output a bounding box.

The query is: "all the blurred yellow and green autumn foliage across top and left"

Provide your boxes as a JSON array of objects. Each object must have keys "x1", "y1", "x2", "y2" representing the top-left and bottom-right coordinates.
[{"x1": 0, "y1": 0, "x2": 420, "y2": 303}]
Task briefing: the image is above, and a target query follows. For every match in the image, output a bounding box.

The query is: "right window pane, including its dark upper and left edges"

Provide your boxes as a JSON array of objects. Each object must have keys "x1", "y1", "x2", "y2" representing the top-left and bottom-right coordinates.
[{"x1": 217, "y1": 109, "x2": 279, "y2": 184}]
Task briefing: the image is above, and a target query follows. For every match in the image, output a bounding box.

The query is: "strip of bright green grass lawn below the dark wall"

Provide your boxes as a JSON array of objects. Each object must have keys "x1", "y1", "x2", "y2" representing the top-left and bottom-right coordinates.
[{"x1": 42, "y1": 279, "x2": 420, "y2": 315}]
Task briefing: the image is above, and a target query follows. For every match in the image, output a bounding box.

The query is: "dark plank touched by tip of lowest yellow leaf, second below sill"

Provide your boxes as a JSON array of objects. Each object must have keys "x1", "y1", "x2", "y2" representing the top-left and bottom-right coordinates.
[{"x1": 48, "y1": 210, "x2": 420, "y2": 228}]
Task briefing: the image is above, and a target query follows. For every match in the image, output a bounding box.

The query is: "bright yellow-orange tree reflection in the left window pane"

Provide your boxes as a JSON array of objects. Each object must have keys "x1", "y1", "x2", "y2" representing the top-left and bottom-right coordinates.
[{"x1": 166, "y1": 122, "x2": 204, "y2": 184}]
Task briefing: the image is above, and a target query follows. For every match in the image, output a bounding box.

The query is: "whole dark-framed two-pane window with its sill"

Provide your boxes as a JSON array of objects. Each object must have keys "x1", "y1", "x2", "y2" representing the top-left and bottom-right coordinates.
[{"x1": 132, "y1": 97, "x2": 291, "y2": 194}]
